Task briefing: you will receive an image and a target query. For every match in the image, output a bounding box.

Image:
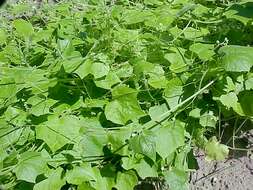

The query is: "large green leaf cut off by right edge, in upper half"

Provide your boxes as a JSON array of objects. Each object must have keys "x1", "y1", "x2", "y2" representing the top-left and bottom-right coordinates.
[{"x1": 219, "y1": 45, "x2": 253, "y2": 72}]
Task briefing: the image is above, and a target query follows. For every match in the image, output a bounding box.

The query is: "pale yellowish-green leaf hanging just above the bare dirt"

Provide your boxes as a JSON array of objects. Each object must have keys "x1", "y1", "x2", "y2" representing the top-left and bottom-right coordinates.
[{"x1": 205, "y1": 137, "x2": 229, "y2": 161}]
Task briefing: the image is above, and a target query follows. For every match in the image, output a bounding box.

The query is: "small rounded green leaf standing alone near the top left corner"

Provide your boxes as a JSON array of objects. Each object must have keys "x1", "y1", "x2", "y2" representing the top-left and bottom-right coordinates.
[{"x1": 13, "y1": 19, "x2": 34, "y2": 38}]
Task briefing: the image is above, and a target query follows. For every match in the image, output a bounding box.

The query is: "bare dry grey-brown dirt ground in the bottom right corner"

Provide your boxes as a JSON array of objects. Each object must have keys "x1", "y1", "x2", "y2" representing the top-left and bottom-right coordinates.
[{"x1": 190, "y1": 150, "x2": 253, "y2": 190}]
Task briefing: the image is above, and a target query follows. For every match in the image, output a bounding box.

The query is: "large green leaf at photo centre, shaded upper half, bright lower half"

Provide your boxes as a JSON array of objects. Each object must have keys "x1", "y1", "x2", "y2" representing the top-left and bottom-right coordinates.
[{"x1": 105, "y1": 85, "x2": 144, "y2": 125}]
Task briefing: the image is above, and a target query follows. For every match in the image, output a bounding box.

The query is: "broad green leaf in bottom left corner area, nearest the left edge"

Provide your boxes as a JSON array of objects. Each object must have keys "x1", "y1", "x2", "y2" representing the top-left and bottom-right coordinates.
[{"x1": 14, "y1": 151, "x2": 47, "y2": 183}]
